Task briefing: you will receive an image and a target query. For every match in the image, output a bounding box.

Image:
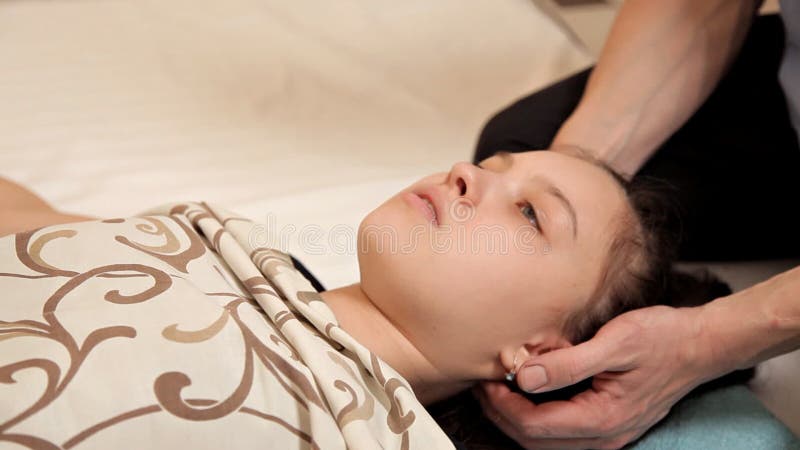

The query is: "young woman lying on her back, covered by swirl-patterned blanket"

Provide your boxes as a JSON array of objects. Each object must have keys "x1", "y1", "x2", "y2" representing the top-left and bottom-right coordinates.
[{"x1": 0, "y1": 151, "x2": 712, "y2": 449}]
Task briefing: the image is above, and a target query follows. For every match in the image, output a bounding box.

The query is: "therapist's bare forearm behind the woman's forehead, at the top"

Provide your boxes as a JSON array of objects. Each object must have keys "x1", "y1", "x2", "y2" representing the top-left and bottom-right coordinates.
[{"x1": 551, "y1": 0, "x2": 761, "y2": 176}]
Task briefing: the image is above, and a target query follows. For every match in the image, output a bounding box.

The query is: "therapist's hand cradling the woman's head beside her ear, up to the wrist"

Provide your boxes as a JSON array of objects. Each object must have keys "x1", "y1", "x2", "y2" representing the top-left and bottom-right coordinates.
[{"x1": 474, "y1": 306, "x2": 724, "y2": 449}]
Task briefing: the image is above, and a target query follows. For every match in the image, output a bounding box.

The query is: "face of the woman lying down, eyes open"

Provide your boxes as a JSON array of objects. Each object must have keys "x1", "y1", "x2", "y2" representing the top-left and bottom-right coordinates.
[{"x1": 358, "y1": 151, "x2": 628, "y2": 378}]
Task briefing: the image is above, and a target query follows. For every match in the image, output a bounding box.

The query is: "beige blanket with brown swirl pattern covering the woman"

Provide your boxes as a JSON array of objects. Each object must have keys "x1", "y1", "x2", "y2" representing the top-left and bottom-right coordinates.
[{"x1": 0, "y1": 203, "x2": 453, "y2": 450}]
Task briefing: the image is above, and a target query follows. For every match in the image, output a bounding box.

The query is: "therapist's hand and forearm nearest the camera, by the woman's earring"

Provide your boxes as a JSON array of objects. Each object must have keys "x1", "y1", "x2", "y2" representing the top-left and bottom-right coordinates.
[{"x1": 474, "y1": 268, "x2": 800, "y2": 448}]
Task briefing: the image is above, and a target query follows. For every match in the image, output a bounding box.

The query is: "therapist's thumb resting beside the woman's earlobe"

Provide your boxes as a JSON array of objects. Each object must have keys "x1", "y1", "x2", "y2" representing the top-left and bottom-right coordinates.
[{"x1": 517, "y1": 340, "x2": 608, "y2": 393}]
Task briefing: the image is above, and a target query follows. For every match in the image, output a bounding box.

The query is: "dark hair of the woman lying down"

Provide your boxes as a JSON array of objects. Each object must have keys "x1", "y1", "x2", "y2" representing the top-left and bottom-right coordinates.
[{"x1": 428, "y1": 163, "x2": 754, "y2": 449}]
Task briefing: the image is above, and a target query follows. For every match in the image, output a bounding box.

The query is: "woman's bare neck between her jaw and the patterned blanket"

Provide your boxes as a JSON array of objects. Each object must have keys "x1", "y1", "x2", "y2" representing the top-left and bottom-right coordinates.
[{"x1": 320, "y1": 283, "x2": 472, "y2": 404}]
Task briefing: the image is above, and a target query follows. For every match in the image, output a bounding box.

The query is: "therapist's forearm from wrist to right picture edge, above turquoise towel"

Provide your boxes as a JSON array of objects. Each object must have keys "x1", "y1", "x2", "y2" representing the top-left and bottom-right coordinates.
[{"x1": 701, "y1": 267, "x2": 800, "y2": 375}]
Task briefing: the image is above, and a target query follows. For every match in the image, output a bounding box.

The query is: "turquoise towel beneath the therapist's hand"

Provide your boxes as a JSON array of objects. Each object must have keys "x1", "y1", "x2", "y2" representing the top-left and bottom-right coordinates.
[{"x1": 626, "y1": 385, "x2": 800, "y2": 450}]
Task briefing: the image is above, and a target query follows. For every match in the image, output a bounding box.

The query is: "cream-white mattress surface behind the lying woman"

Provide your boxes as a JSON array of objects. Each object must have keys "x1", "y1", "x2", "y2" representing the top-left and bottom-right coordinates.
[{"x1": 0, "y1": 0, "x2": 800, "y2": 440}]
